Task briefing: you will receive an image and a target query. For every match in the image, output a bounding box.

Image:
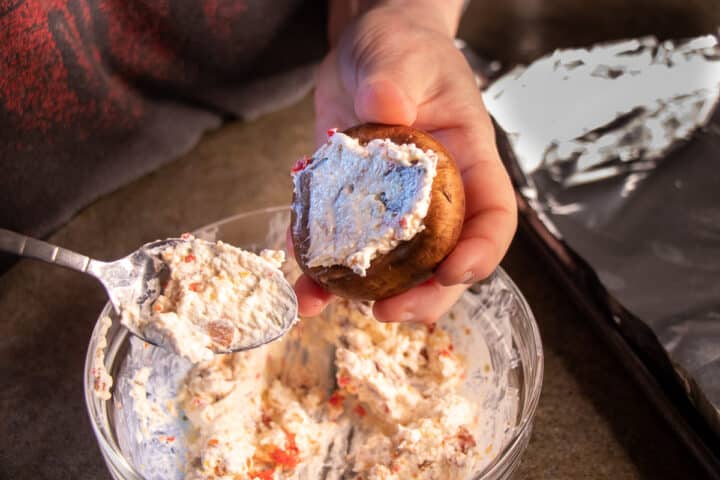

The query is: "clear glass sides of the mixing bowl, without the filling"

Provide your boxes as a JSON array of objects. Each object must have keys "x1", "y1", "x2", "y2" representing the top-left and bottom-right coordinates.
[{"x1": 84, "y1": 207, "x2": 543, "y2": 480}]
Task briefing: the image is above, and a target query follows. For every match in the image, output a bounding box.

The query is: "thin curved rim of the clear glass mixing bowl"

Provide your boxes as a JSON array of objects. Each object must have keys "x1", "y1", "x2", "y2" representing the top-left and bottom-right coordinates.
[{"x1": 83, "y1": 206, "x2": 544, "y2": 480}]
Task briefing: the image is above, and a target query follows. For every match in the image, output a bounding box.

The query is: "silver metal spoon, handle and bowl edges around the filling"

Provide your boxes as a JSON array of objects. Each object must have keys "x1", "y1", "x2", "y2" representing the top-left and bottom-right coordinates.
[{"x1": 0, "y1": 228, "x2": 298, "y2": 353}]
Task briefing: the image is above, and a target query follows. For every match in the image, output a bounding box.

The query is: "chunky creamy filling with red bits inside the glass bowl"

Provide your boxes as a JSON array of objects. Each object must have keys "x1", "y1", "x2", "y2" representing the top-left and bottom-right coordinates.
[{"x1": 179, "y1": 300, "x2": 480, "y2": 480}]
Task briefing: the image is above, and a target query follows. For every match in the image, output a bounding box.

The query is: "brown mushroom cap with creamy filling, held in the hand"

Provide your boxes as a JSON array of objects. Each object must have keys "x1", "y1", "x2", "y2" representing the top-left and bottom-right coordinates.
[{"x1": 291, "y1": 124, "x2": 465, "y2": 300}]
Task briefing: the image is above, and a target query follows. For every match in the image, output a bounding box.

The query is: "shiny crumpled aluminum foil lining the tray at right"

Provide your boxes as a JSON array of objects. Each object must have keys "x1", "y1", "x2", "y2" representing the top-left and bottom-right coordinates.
[{"x1": 484, "y1": 35, "x2": 720, "y2": 442}]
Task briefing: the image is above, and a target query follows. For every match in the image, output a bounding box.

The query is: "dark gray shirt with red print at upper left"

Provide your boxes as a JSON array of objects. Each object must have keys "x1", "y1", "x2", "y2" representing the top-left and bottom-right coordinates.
[{"x1": 0, "y1": 0, "x2": 326, "y2": 242}]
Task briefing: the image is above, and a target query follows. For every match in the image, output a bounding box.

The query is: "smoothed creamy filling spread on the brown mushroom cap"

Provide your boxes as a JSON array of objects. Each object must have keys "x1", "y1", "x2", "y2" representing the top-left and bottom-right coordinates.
[{"x1": 293, "y1": 132, "x2": 438, "y2": 276}]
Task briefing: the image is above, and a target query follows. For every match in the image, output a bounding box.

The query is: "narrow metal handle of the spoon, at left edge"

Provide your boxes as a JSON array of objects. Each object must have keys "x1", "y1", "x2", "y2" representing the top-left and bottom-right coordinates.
[{"x1": 0, "y1": 228, "x2": 93, "y2": 272}]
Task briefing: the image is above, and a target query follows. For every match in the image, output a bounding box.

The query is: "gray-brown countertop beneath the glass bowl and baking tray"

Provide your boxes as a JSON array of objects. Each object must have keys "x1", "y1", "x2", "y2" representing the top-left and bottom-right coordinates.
[{"x1": 0, "y1": 95, "x2": 702, "y2": 480}]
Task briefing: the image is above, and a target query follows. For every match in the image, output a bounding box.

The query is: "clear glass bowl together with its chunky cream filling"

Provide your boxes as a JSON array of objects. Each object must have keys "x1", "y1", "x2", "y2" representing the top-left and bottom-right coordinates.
[{"x1": 84, "y1": 207, "x2": 543, "y2": 480}]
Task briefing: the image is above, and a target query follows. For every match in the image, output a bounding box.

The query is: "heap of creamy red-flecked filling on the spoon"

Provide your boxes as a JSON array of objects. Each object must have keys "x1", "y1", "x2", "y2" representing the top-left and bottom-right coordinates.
[{"x1": 121, "y1": 237, "x2": 289, "y2": 362}]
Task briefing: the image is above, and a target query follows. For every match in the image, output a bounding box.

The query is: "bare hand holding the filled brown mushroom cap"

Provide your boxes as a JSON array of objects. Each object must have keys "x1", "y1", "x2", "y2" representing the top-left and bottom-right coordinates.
[{"x1": 295, "y1": 2, "x2": 517, "y2": 323}]
